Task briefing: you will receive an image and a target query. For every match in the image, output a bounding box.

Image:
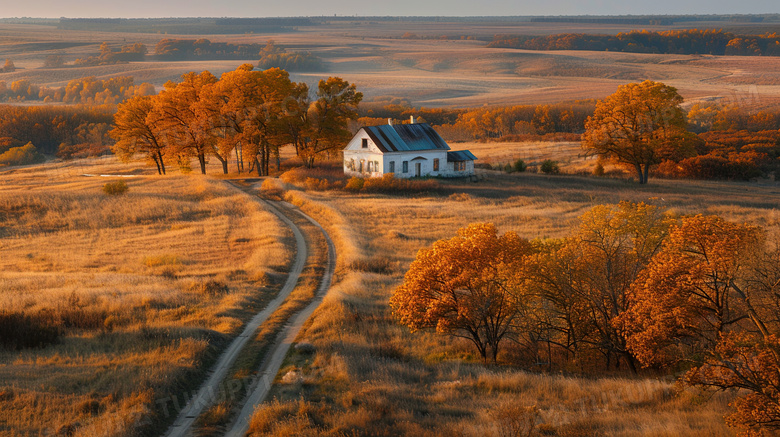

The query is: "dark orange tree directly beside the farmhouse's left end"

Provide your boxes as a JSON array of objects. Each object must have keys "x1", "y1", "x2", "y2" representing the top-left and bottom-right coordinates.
[{"x1": 298, "y1": 77, "x2": 363, "y2": 167}]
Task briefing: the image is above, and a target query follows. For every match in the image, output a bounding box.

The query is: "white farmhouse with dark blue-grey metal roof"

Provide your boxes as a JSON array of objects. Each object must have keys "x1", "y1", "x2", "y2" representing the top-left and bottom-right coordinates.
[{"x1": 344, "y1": 117, "x2": 477, "y2": 178}]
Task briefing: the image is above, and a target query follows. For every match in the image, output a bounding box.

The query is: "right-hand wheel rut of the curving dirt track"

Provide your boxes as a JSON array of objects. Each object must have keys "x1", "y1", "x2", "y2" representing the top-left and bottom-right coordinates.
[{"x1": 225, "y1": 205, "x2": 336, "y2": 437}]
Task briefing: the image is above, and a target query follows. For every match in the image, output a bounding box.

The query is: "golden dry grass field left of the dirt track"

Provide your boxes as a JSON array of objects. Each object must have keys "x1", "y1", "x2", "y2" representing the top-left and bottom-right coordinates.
[{"x1": 0, "y1": 158, "x2": 291, "y2": 436}]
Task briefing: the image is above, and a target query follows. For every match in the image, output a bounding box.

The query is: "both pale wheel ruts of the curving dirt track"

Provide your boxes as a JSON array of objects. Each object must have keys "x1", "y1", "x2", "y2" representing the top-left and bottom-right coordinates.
[{"x1": 164, "y1": 181, "x2": 336, "y2": 437}]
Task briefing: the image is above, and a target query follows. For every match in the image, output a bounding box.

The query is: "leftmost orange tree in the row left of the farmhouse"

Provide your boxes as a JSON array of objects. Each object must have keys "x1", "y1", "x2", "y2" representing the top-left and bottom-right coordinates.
[{"x1": 110, "y1": 96, "x2": 167, "y2": 175}]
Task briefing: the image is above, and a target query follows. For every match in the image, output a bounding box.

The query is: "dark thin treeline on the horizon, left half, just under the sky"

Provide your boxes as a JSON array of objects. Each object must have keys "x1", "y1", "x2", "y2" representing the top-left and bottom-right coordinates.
[{"x1": 57, "y1": 18, "x2": 314, "y2": 35}]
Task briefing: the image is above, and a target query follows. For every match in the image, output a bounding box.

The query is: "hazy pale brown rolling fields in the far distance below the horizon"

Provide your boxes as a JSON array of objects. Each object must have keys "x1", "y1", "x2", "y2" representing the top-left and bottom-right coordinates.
[{"x1": 0, "y1": 21, "x2": 780, "y2": 107}]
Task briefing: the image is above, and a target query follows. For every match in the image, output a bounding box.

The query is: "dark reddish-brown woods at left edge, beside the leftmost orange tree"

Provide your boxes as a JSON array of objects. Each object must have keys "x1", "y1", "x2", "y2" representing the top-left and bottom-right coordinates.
[{"x1": 0, "y1": 105, "x2": 115, "y2": 158}]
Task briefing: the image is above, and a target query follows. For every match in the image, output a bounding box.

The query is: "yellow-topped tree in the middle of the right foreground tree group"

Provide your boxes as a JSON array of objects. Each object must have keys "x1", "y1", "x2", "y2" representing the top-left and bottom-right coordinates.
[{"x1": 534, "y1": 202, "x2": 673, "y2": 371}]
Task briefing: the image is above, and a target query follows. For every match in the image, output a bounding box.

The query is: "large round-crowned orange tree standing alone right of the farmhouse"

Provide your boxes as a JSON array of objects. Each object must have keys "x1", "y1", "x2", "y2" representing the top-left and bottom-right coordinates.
[{"x1": 582, "y1": 80, "x2": 691, "y2": 184}]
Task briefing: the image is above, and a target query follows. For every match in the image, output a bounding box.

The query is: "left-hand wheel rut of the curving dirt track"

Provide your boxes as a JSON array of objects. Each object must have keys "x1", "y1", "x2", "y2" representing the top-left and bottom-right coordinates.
[{"x1": 165, "y1": 185, "x2": 310, "y2": 437}]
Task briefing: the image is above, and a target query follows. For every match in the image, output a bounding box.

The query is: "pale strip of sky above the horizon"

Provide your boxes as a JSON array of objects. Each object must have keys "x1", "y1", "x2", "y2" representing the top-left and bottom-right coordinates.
[{"x1": 0, "y1": 0, "x2": 780, "y2": 18}]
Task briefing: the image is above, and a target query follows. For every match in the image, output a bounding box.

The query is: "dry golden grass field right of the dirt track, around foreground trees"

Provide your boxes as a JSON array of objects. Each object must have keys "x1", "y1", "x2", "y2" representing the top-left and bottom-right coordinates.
[{"x1": 252, "y1": 158, "x2": 780, "y2": 436}]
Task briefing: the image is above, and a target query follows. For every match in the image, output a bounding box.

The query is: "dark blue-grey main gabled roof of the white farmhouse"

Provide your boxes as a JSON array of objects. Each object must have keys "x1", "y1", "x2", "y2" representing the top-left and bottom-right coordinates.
[{"x1": 363, "y1": 123, "x2": 450, "y2": 153}]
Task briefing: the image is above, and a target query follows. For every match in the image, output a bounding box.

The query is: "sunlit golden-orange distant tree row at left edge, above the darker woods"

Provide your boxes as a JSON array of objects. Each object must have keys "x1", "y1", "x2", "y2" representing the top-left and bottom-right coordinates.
[{"x1": 0, "y1": 76, "x2": 157, "y2": 105}]
